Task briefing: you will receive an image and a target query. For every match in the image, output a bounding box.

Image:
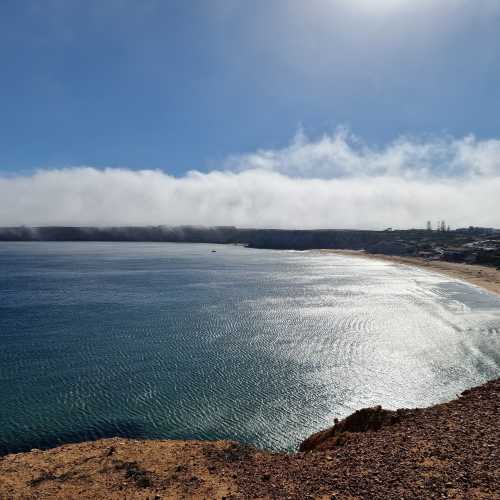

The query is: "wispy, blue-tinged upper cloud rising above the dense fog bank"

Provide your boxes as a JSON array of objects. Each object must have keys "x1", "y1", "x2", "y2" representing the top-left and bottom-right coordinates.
[{"x1": 226, "y1": 128, "x2": 500, "y2": 179}]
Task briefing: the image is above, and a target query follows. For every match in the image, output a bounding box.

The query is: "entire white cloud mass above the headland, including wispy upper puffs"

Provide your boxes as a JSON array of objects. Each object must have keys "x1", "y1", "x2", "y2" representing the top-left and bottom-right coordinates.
[{"x1": 0, "y1": 129, "x2": 500, "y2": 229}]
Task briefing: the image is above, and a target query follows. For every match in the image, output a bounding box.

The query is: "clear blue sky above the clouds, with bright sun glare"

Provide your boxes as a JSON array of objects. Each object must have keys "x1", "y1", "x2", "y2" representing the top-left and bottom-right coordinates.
[{"x1": 0, "y1": 0, "x2": 500, "y2": 175}]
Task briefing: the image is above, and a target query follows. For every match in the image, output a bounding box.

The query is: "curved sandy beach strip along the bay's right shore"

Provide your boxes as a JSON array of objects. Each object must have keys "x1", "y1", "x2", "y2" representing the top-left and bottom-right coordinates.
[{"x1": 319, "y1": 249, "x2": 500, "y2": 295}]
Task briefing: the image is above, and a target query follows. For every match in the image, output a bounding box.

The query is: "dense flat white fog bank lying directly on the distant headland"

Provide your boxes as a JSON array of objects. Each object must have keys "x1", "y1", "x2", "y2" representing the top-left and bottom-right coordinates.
[{"x1": 0, "y1": 168, "x2": 500, "y2": 229}]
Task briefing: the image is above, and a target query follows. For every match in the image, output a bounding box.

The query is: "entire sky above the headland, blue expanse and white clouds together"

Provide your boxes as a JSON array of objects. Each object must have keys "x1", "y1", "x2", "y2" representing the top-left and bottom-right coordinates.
[{"x1": 0, "y1": 0, "x2": 500, "y2": 229}]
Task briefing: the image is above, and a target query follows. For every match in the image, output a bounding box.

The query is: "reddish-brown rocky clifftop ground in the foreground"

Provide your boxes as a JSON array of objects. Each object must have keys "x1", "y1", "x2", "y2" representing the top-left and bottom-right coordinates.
[{"x1": 0, "y1": 379, "x2": 500, "y2": 499}]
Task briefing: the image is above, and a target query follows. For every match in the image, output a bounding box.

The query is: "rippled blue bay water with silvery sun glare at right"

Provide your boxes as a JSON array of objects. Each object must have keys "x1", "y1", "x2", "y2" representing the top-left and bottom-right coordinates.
[{"x1": 0, "y1": 243, "x2": 500, "y2": 453}]
